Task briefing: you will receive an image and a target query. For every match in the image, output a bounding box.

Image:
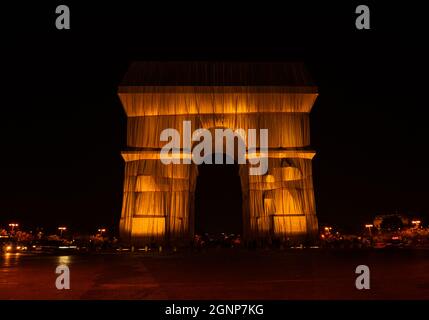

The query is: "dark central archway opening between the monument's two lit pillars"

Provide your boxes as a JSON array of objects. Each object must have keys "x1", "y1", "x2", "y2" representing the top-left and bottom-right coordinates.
[{"x1": 195, "y1": 155, "x2": 243, "y2": 235}]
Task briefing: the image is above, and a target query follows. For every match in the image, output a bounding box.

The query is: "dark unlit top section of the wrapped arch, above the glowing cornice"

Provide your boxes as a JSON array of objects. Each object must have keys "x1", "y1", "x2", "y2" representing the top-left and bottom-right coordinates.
[{"x1": 120, "y1": 61, "x2": 317, "y2": 93}]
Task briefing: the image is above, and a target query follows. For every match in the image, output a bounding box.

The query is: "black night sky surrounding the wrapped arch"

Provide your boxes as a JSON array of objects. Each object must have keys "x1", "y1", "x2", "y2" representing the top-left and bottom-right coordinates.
[{"x1": 0, "y1": 1, "x2": 429, "y2": 230}]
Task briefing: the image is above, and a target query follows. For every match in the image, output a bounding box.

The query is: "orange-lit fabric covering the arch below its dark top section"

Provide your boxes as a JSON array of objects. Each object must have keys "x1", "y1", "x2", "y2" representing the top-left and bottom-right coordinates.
[{"x1": 119, "y1": 86, "x2": 317, "y2": 243}]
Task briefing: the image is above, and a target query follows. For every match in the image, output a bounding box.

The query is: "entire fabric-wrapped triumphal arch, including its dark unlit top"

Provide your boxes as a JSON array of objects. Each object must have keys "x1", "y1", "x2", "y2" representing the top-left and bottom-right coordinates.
[{"x1": 118, "y1": 62, "x2": 318, "y2": 244}]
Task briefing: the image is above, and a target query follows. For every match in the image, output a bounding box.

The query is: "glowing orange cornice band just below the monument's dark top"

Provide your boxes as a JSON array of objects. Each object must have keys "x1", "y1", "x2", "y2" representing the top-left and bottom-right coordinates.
[{"x1": 119, "y1": 86, "x2": 317, "y2": 117}]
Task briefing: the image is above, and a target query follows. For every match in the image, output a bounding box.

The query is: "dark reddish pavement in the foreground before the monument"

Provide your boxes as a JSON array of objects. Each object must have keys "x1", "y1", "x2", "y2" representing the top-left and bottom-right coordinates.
[{"x1": 0, "y1": 249, "x2": 429, "y2": 299}]
